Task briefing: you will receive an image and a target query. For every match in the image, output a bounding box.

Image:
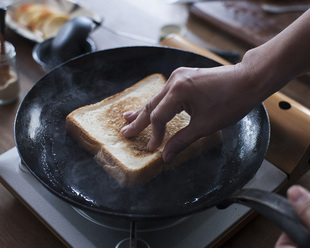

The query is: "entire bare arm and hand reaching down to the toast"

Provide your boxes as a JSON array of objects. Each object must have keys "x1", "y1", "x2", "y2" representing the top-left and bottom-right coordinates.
[{"x1": 122, "y1": 11, "x2": 310, "y2": 162}]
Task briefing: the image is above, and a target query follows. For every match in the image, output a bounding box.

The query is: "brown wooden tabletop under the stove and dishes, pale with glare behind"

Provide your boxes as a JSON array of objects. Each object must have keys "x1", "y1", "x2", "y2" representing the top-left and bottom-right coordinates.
[{"x1": 0, "y1": 0, "x2": 310, "y2": 248}]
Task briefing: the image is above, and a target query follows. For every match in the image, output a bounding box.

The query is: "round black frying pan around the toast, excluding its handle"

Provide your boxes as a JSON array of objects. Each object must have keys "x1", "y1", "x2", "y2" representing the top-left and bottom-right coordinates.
[{"x1": 15, "y1": 47, "x2": 310, "y2": 246}]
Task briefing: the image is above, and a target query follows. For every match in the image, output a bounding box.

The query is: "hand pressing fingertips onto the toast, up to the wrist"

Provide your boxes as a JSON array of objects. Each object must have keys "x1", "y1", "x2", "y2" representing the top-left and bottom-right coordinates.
[{"x1": 121, "y1": 64, "x2": 259, "y2": 163}]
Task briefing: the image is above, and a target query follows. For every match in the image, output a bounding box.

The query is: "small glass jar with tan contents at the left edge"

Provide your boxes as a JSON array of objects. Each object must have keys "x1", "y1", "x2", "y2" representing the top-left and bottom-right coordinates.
[{"x1": 0, "y1": 41, "x2": 19, "y2": 105}]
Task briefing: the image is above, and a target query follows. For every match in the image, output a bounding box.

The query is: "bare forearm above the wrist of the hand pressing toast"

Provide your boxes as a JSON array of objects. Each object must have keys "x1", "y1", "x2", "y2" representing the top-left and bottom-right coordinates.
[{"x1": 241, "y1": 10, "x2": 310, "y2": 101}]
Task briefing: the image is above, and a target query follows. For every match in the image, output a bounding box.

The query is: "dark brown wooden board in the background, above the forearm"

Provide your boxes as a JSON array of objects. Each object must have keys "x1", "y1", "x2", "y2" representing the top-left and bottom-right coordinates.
[{"x1": 190, "y1": 0, "x2": 309, "y2": 46}]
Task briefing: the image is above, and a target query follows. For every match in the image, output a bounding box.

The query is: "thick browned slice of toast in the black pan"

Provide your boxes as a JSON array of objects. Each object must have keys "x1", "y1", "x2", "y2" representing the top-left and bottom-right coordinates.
[{"x1": 66, "y1": 74, "x2": 221, "y2": 186}]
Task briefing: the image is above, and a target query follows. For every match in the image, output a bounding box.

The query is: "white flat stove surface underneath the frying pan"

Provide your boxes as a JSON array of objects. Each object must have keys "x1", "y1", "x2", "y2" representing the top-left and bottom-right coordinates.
[{"x1": 0, "y1": 147, "x2": 287, "y2": 248}]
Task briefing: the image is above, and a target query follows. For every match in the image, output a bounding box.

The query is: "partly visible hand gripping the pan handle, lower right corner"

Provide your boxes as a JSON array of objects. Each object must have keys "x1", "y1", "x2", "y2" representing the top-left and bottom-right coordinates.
[{"x1": 275, "y1": 186, "x2": 310, "y2": 248}]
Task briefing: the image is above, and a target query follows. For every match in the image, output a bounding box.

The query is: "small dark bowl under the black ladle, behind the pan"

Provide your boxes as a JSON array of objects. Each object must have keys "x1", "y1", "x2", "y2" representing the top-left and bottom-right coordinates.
[{"x1": 32, "y1": 38, "x2": 96, "y2": 71}]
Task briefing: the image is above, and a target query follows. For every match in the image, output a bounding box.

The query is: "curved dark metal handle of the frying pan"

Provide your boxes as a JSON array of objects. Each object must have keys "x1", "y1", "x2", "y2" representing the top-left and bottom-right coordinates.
[{"x1": 217, "y1": 189, "x2": 310, "y2": 248}]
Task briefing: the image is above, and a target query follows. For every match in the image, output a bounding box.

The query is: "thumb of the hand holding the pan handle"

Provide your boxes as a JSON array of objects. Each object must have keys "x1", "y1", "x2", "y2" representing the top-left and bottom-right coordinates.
[{"x1": 287, "y1": 185, "x2": 310, "y2": 228}]
